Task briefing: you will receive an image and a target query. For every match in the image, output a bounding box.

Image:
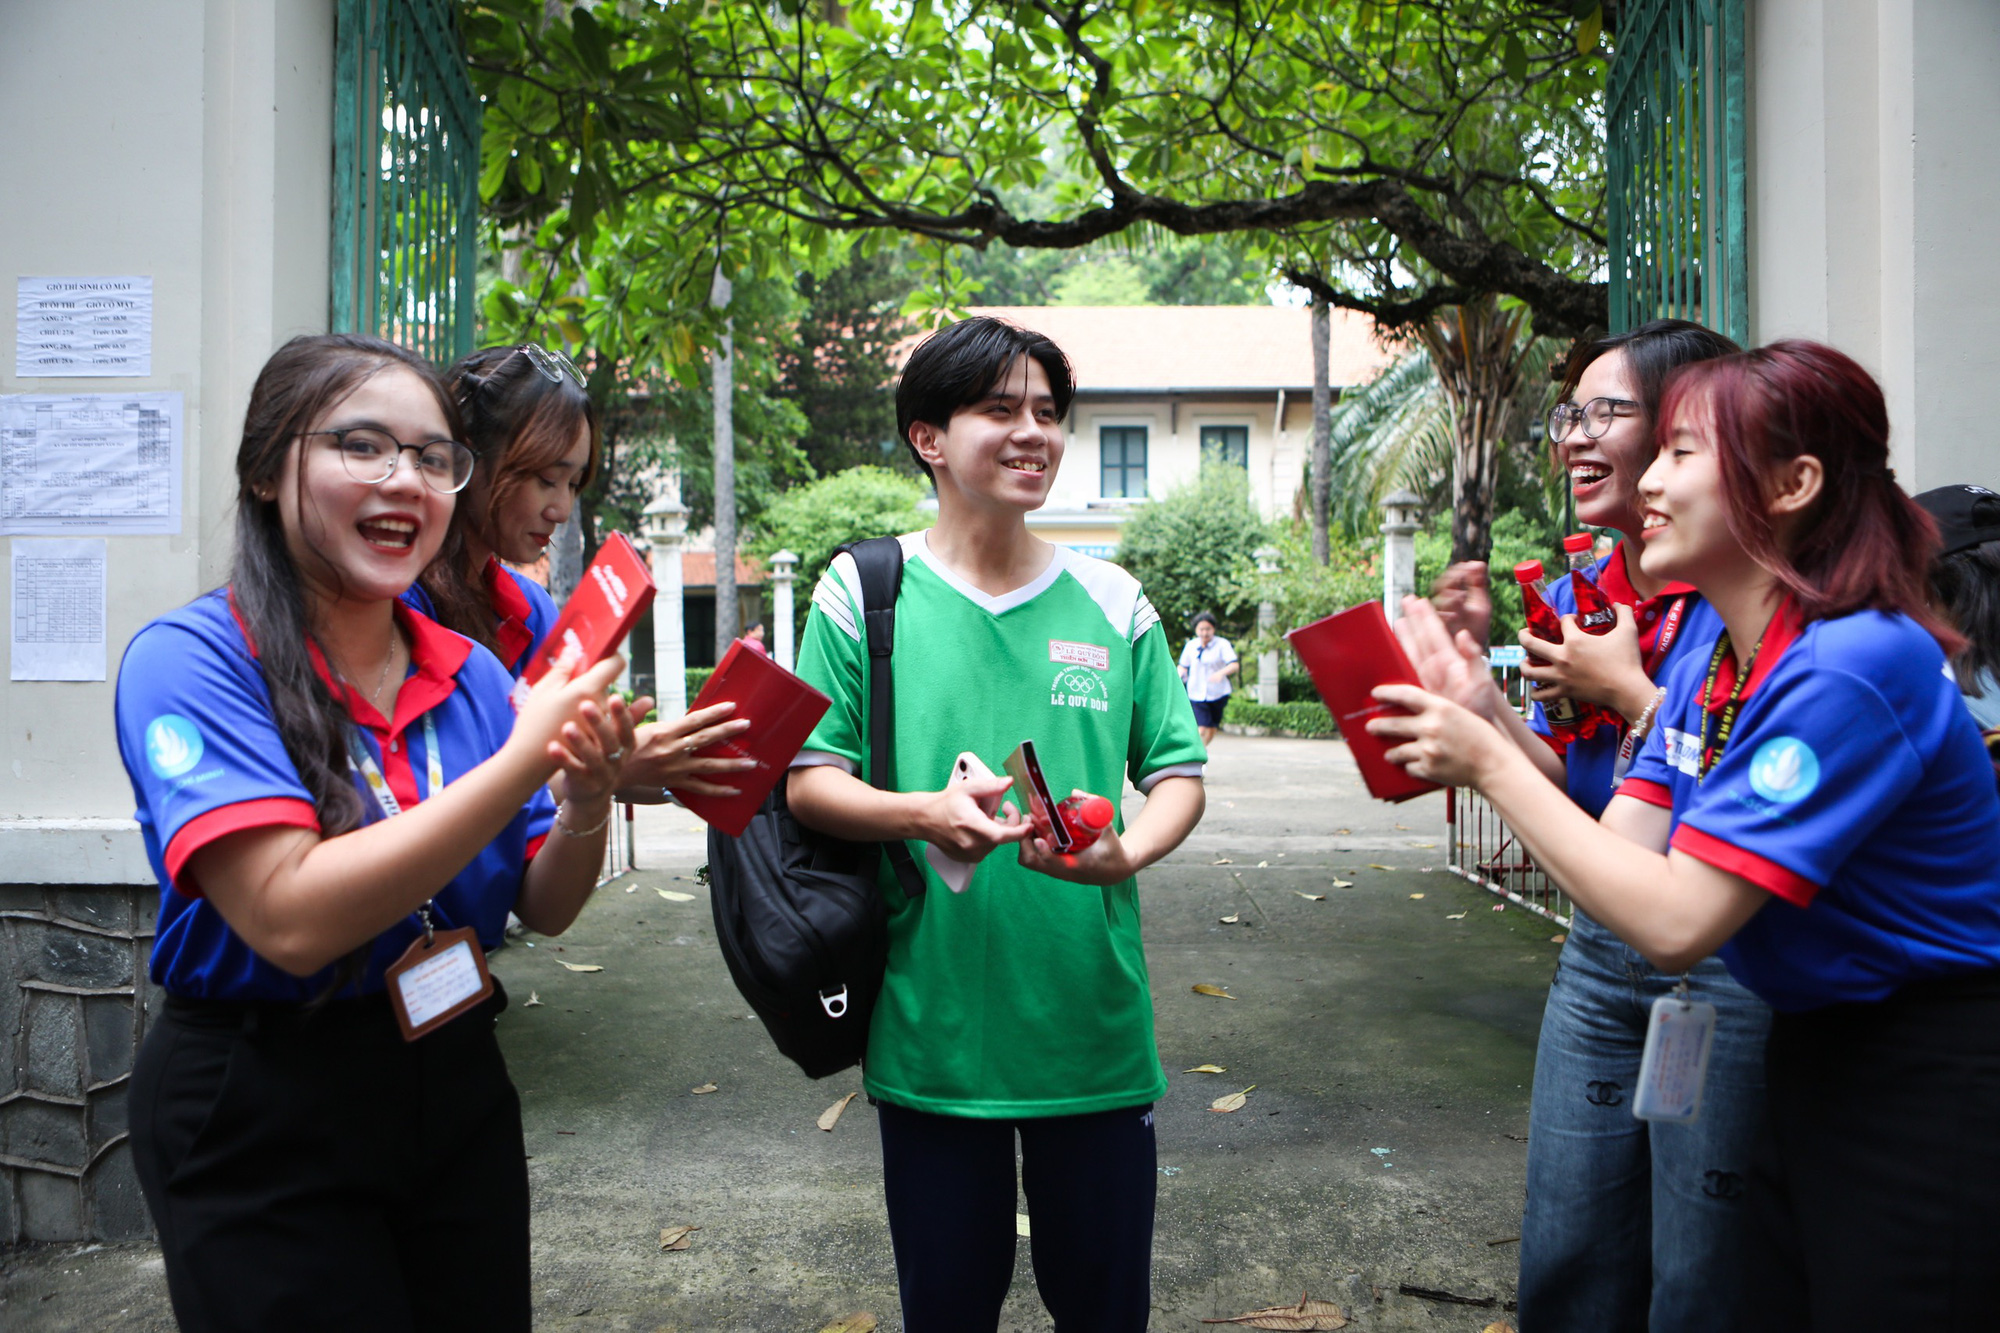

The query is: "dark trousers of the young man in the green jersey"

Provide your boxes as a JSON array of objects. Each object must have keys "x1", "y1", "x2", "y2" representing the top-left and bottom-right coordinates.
[{"x1": 880, "y1": 1103, "x2": 1158, "y2": 1333}]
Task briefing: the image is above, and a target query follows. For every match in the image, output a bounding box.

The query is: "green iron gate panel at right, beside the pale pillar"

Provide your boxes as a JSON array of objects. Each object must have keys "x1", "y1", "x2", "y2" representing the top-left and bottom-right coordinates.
[{"x1": 1604, "y1": 0, "x2": 1750, "y2": 342}]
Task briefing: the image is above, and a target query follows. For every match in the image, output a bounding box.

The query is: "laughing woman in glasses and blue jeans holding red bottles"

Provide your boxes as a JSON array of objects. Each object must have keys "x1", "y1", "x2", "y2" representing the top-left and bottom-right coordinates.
[{"x1": 1438, "y1": 320, "x2": 1770, "y2": 1333}]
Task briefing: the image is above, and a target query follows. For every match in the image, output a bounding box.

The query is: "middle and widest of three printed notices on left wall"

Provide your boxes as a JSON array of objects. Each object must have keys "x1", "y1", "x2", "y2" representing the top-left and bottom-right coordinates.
[{"x1": 0, "y1": 390, "x2": 182, "y2": 536}]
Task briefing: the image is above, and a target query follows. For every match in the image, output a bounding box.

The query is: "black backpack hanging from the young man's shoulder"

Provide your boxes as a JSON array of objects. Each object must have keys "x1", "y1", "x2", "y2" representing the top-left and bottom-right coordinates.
[{"x1": 708, "y1": 536, "x2": 924, "y2": 1079}]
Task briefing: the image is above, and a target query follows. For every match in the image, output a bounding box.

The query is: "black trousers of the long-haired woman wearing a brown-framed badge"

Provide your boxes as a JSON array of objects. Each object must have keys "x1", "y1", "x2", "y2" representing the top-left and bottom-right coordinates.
[{"x1": 132, "y1": 985, "x2": 528, "y2": 1333}]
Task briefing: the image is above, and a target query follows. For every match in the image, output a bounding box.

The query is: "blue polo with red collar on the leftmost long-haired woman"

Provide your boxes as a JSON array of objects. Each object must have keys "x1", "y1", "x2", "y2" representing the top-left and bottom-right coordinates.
[{"x1": 118, "y1": 592, "x2": 556, "y2": 1001}]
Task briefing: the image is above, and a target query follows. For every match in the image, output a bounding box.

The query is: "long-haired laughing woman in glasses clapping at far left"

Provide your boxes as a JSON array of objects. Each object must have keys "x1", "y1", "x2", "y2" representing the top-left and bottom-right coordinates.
[{"x1": 118, "y1": 334, "x2": 634, "y2": 1331}]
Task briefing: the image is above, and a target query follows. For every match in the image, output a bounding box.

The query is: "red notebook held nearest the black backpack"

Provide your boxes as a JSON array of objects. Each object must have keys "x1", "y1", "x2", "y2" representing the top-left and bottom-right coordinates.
[{"x1": 668, "y1": 638, "x2": 834, "y2": 839}]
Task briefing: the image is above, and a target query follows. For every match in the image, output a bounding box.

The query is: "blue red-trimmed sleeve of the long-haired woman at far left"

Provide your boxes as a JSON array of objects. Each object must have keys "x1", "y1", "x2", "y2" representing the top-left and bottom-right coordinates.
[{"x1": 116, "y1": 602, "x2": 318, "y2": 895}]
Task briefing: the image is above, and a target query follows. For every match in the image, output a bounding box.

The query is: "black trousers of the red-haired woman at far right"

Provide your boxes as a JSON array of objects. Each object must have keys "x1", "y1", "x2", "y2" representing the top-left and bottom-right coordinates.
[{"x1": 1744, "y1": 973, "x2": 2000, "y2": 1333}]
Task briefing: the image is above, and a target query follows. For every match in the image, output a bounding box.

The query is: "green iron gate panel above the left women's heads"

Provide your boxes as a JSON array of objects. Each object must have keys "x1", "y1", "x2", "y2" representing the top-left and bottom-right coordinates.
[{"x1": 328, "y1": 0, "x2": 480, "y2": 362}]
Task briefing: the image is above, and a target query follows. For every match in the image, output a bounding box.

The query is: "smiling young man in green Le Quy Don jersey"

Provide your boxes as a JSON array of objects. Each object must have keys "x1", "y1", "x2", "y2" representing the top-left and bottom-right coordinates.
[{"x1": 790, "y1": 318, "x2": 1206, "y2": 1333}]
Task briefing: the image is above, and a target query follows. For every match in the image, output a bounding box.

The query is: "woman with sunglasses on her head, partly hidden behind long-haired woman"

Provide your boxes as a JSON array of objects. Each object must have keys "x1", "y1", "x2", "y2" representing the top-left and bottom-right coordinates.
[{"x1": 414, "y1": 342, "x2": 756, "y2": 805}]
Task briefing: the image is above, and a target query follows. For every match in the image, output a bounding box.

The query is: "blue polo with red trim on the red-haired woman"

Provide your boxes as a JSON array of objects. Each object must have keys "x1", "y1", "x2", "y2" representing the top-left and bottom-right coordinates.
[{"x1": 1618, "y1": 604, "x2": 2000, "y2": 1011}]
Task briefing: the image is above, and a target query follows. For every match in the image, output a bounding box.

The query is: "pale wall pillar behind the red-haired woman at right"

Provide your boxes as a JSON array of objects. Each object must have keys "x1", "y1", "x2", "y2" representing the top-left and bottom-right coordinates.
[{"x1": 1748, "y1": 0, "x2": 2000, "y2": 492}]
